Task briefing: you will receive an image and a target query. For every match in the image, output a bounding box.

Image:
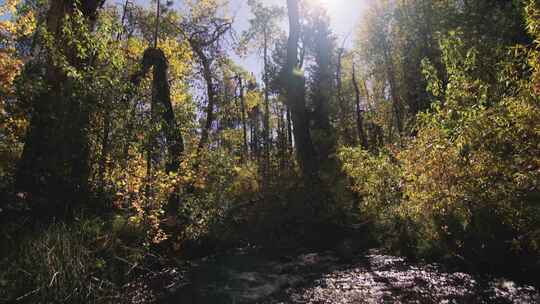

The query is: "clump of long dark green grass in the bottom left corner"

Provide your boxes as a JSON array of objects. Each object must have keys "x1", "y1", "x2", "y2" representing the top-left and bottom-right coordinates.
[{"x1": 0, "y1": 216, "x2": 146, "y2": 303}]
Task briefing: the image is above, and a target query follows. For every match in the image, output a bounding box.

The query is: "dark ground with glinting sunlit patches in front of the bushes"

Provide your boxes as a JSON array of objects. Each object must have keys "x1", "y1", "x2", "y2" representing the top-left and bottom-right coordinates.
[{"x1": 126, "y1": 249, "x2": 540, "y2": 304}]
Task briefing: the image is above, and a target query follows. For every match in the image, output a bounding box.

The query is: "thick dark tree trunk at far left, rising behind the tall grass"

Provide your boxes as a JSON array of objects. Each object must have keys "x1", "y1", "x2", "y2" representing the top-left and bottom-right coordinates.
[{"x1": 16, "y1": 0, "x2": 104, "y2": 215}]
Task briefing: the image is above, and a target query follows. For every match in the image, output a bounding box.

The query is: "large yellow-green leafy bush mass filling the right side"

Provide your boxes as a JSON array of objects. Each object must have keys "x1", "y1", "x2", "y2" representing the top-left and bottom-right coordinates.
[{"x1": 341, "y1": 29, "x2": 540, "y2": 267}]
